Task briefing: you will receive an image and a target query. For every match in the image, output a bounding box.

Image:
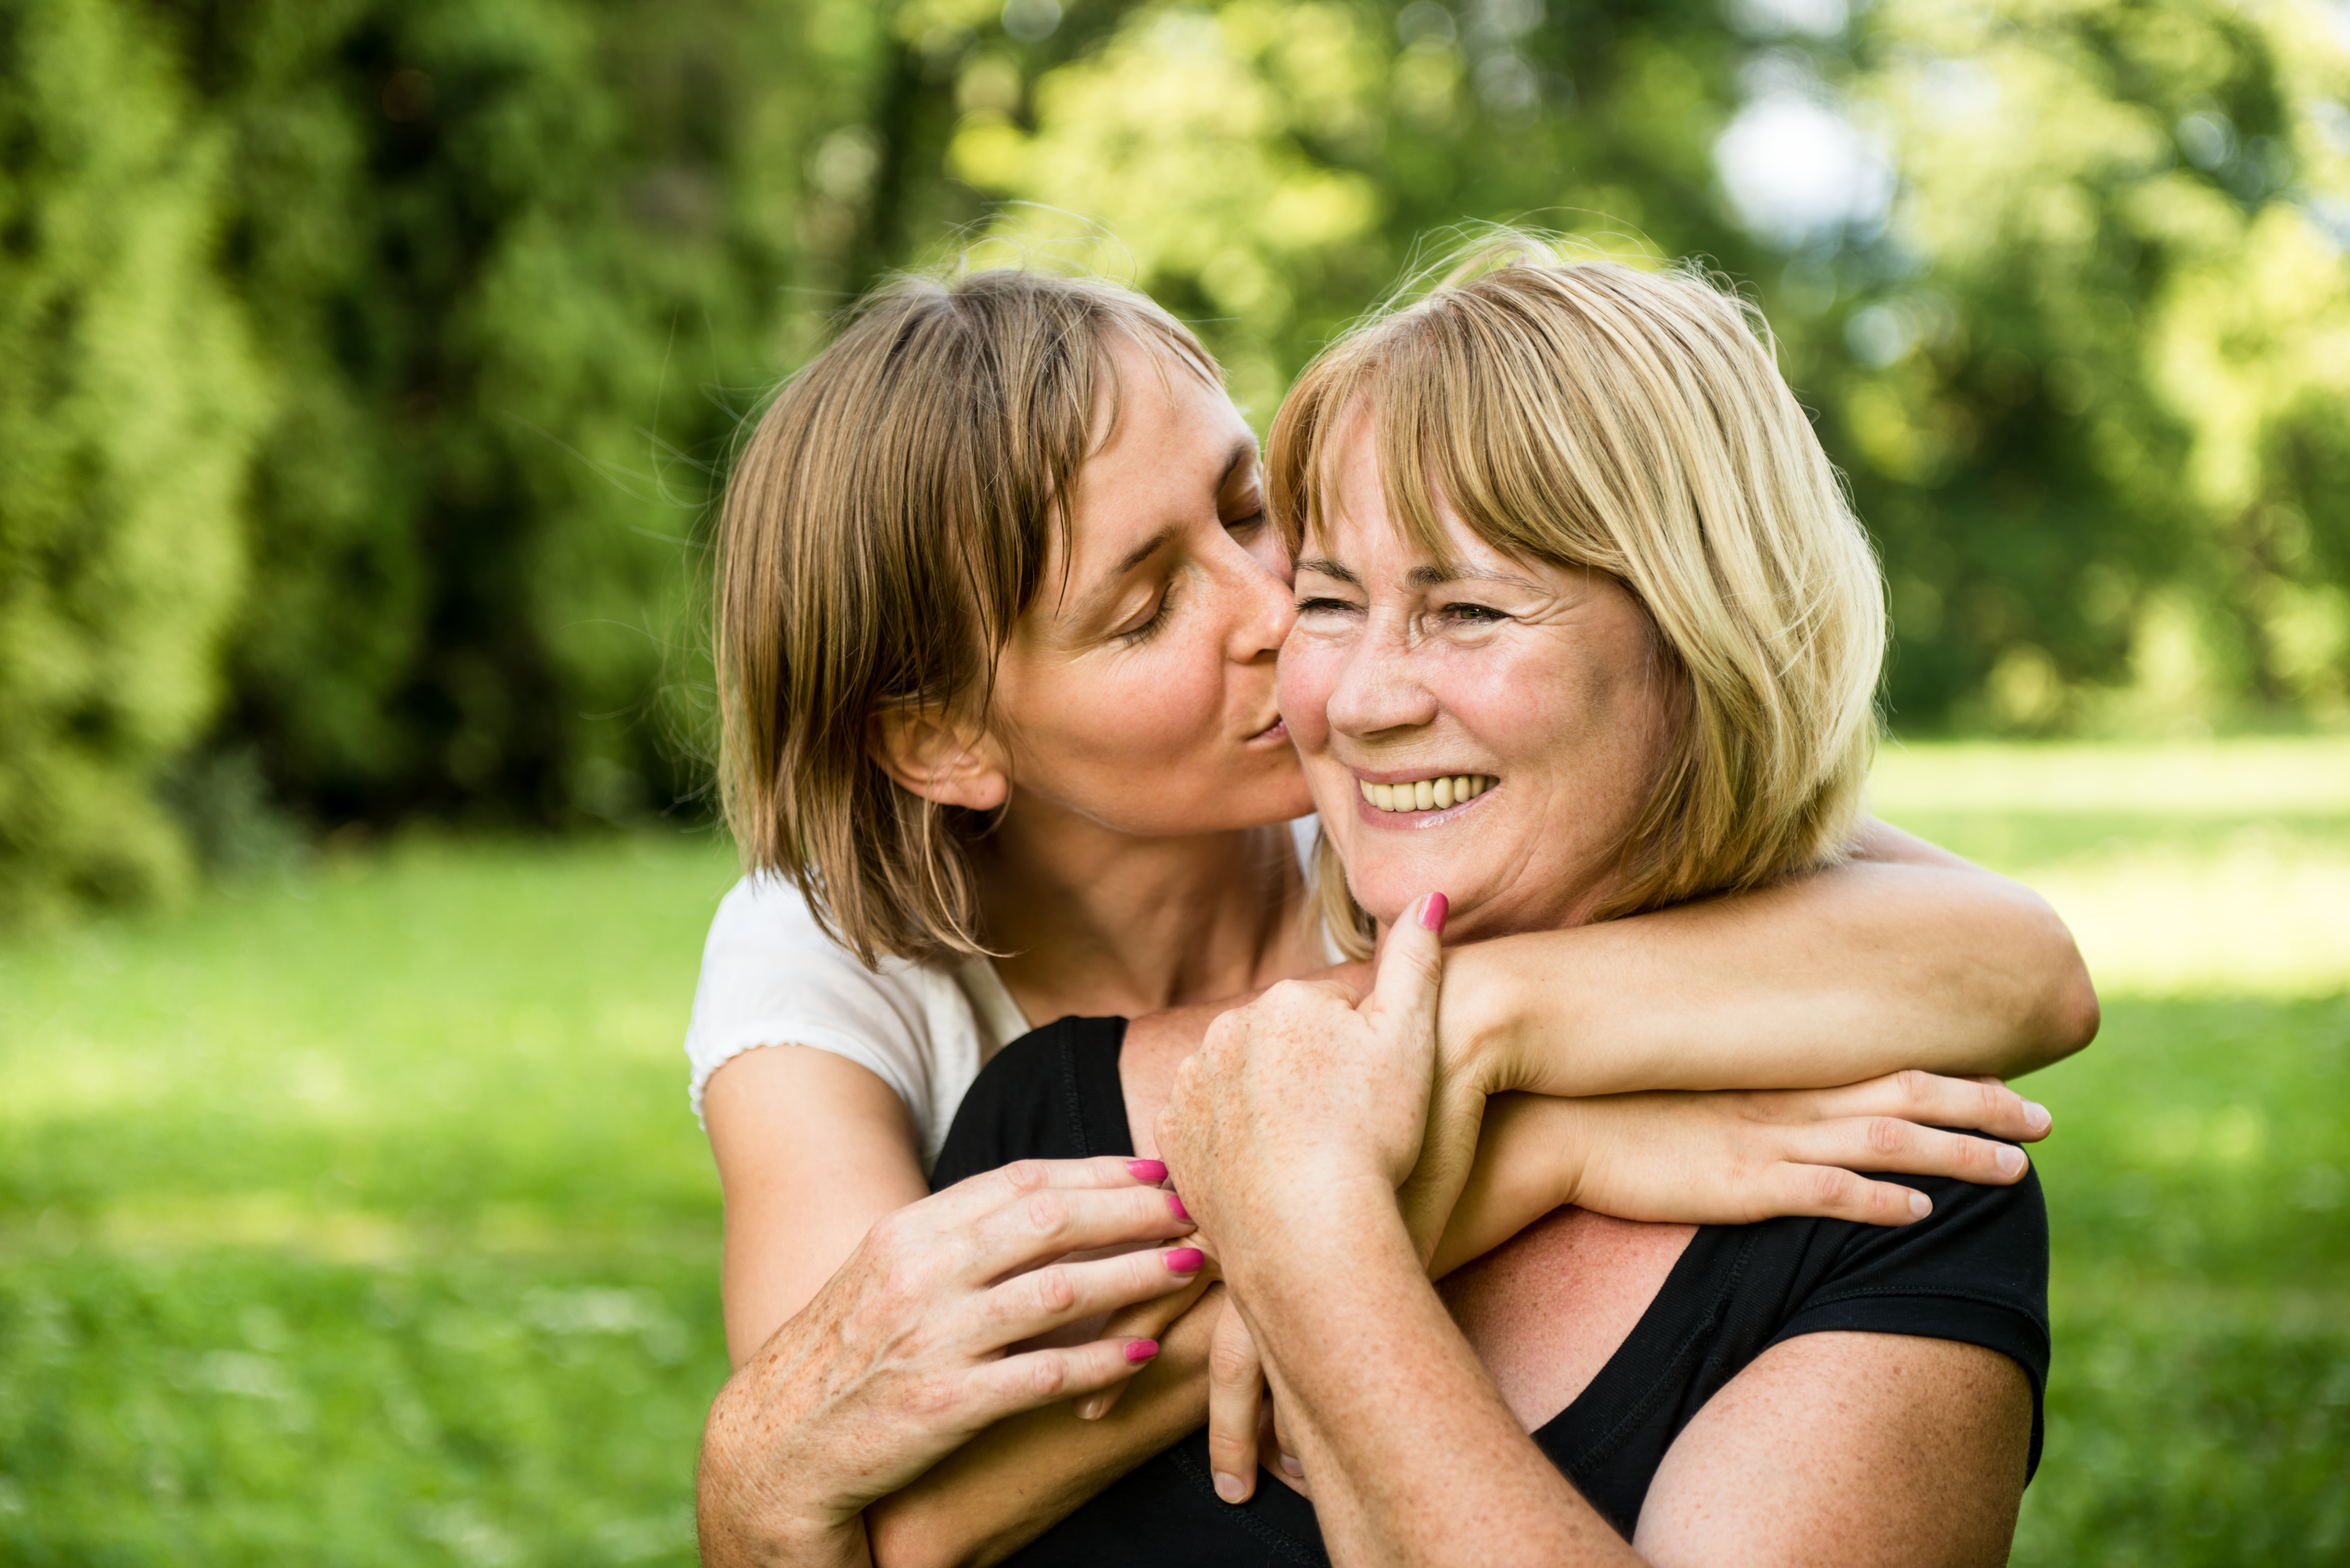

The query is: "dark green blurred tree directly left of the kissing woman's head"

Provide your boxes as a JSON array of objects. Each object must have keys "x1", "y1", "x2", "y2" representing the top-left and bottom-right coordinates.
[{"x1": 174, "y1": 0, "x2": 846, "y2": 825}]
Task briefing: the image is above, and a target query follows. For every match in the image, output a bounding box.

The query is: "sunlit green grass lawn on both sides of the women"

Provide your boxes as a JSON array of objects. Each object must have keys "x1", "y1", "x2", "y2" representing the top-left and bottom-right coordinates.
[{"x1": 0, "y1": 740, "x2": 2350, "y2": 1568}]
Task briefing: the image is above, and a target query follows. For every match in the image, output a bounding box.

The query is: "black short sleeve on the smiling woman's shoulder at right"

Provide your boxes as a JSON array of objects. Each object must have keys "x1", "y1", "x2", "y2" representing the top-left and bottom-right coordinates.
[{"x1": 1765, "y1": 1166, "x2": 2049, "y2": 1469}]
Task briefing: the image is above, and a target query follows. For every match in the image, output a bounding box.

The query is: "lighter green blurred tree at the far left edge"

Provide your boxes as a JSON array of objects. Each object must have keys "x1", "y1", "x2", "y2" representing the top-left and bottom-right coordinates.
[{"x1": 0, "y1": 0, "x2": 266, "y2": 924}]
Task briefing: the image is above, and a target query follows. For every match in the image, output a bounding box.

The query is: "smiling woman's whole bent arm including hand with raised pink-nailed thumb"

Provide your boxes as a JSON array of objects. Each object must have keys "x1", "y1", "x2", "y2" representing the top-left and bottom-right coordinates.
[{"x1": 1161, "y1": 907, "x2": 2030, "y2": 1568}]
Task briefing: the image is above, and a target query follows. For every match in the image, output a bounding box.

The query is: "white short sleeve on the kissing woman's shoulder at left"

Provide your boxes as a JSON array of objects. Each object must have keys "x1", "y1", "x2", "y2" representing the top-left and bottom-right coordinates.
[{"x1": 686, "y1": 877, "x2": 959, "y2": 1152}]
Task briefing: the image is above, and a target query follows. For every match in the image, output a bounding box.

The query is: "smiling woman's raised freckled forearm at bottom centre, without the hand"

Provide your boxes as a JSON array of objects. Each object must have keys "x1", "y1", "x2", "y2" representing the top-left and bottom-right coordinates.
[{"x1": 1234, "y1": 1190, "x2": 1636, "y2": 1563}]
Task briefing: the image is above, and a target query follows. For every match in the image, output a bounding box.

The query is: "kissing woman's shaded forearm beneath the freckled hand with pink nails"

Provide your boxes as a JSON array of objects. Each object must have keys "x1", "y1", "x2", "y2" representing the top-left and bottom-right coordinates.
[{"x1": 865, "y1": 1293, "x2": 1222, "y2": 1568}]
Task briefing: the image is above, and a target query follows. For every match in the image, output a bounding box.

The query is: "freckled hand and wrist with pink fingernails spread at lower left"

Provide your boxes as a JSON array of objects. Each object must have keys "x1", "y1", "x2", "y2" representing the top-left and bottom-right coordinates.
[{"x1": 698, "y1": 1159, "x2": 1208, "y2": 1563}]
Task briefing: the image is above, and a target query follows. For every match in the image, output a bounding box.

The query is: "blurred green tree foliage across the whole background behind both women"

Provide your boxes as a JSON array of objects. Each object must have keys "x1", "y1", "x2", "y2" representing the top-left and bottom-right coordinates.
[{"x1": 0, "y1": 0, "x2": 2350, "y2": 907}]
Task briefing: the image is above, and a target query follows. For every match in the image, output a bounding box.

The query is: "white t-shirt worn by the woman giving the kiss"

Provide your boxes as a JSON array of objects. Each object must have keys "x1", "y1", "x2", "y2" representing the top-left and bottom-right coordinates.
[{"x1": 686, "y1": 816, "x2": 1335, "y2": 1171}]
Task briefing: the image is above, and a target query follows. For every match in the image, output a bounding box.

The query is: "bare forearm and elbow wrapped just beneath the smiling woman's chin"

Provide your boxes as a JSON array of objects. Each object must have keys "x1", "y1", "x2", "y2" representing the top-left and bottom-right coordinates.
[{"x1": 1438, "y1": 830, "x2": 2096, "y2": 1096}]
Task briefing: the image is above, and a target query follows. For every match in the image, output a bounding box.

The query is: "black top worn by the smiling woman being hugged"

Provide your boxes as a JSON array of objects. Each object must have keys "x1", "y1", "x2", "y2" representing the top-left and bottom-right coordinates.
[{"x1": 931, "y1": 1018, "x2": 2049, "y2": 1568}]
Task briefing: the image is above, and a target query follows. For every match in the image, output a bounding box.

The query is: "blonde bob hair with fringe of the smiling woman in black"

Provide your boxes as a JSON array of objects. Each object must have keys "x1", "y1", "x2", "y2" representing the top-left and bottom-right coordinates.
[{"x1": 1269, "y1": 233, "x2": 1885, "y2": 945}]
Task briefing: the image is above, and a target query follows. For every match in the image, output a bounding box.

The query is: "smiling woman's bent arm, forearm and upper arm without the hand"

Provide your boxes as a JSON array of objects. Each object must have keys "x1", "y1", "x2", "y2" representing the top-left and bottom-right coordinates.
[{"x1": 1227, "y1": 1185, "x2": 2030, "y2": 1568}]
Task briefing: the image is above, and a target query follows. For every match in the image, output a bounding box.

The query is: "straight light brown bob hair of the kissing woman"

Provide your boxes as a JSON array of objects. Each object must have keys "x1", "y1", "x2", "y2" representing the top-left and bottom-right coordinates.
[{"x1": 714, "y1": 270, "x2": 1222, "y2": 964}]
